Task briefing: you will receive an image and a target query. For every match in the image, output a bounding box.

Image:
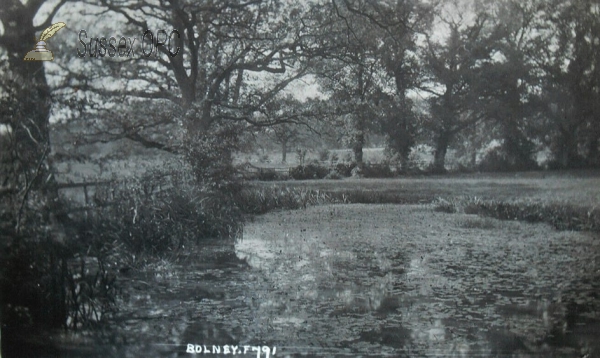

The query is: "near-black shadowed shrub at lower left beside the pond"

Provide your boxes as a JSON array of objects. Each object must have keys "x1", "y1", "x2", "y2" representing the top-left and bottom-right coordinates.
[{"x1": 0, "y1": 232, "x2": 117, "y2": 333}]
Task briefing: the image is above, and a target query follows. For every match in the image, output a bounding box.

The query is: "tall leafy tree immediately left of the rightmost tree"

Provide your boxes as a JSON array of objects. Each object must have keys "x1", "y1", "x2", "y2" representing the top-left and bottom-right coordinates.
[{"x1": 480, "y1": 0, "x2": 544, "y2": 169}]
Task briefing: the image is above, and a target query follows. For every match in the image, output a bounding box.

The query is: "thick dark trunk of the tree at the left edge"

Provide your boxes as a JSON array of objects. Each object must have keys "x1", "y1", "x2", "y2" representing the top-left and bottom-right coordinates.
[{"x1": 0, "y1": 1, "x2": 66, "y2": 238}]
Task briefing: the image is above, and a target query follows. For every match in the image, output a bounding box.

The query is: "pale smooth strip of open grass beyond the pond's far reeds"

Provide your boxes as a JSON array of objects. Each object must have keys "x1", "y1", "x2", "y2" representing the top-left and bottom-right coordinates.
[{"x1": 252, "y1": 171, "x2": 600, "y2": 206}]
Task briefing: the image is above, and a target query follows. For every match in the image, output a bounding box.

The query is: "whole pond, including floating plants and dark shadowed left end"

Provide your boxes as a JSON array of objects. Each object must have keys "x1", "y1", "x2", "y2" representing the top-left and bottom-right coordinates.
[{"x1": 5, "y1": 205, "x2": 600, "y2": 358}]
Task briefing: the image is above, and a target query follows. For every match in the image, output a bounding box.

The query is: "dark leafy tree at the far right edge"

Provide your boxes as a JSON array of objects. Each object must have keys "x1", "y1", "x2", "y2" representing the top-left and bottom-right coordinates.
[{"x1": 538, "y1": 0, "x2": 600, "y2": 168}]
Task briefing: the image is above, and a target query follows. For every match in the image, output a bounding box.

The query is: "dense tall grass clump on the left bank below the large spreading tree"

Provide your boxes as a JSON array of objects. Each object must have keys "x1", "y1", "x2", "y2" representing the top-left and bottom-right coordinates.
[{"x1": 78, "y1": 169, "x2": 242, "y2": 259}]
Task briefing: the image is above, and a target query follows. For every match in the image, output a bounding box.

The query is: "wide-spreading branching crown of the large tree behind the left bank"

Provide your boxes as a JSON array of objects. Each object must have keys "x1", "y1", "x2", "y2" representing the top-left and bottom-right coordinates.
[{"x1": 50, "y1": 0, "x2": 329, "y2": 185}]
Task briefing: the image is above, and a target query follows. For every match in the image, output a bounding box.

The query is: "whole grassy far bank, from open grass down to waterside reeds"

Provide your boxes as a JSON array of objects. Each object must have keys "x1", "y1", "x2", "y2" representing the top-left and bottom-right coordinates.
[{"x1": 247, "y1": 171, "x2": 600, "y2": 231}]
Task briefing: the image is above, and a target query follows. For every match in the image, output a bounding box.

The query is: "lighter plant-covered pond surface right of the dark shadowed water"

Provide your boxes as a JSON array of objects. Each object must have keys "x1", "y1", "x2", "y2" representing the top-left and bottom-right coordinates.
[{"x1": 232, "y1": 205, "x2": 600, "y2": 356}]
